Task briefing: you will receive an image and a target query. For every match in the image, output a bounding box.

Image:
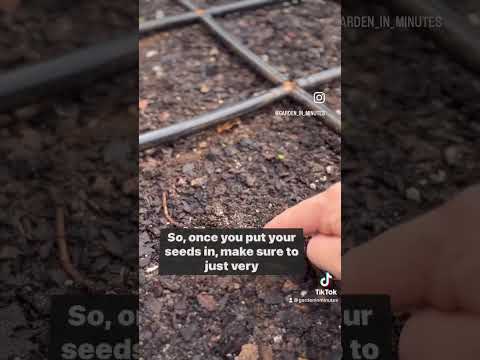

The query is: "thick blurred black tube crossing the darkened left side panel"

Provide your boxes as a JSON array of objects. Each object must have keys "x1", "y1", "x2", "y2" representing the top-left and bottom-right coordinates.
[{"x1": 0, "y1": 33, "x2": 138, "y2": 112}]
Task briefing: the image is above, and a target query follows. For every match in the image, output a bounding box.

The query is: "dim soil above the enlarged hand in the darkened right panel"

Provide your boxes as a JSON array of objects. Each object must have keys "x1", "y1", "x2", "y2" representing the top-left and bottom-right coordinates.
[{"x1": 342, "y1": 1, "x2": 480, "y2": 358}]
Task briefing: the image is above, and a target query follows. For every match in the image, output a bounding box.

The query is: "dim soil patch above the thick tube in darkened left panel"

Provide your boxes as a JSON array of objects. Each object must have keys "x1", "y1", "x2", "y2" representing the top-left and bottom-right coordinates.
[{"x1": 0, "y1": 0, "x2": 137, "y2": 71}]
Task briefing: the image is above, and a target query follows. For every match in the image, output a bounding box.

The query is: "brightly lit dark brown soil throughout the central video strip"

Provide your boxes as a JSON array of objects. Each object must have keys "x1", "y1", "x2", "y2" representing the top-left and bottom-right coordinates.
[{"x1": 140, "y1": 0, "x2": 340, "y2": 360}]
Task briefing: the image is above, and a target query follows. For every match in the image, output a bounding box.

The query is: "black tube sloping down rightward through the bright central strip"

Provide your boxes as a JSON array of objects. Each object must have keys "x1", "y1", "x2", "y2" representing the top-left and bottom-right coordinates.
[{"x1": 178, "y1": 0, "x2": 341, "y2": 134}]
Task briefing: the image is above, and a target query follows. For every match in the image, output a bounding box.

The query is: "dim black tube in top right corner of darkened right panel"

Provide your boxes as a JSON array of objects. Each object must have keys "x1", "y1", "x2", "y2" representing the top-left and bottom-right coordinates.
[{"x1": 392, "y1": 0, "x2": 480, "y2": 72}]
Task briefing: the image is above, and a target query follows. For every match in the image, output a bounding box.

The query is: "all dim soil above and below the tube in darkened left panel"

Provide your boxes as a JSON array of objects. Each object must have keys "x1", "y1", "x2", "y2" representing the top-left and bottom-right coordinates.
[{"x1": 0, "y1": 1, "x2": 138, "y2": 360}]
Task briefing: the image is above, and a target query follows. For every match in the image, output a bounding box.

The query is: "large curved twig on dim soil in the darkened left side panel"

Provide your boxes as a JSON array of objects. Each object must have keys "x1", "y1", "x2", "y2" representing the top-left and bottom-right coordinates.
[{"x1": 56, "y1": 205, "x2": 95, "y2": 290}]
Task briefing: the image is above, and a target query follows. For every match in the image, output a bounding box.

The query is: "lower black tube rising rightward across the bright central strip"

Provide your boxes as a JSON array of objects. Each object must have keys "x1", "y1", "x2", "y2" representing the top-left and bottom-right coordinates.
[{"x1": 139, "y1": 67, "x2": 341, "y2": 150}]
